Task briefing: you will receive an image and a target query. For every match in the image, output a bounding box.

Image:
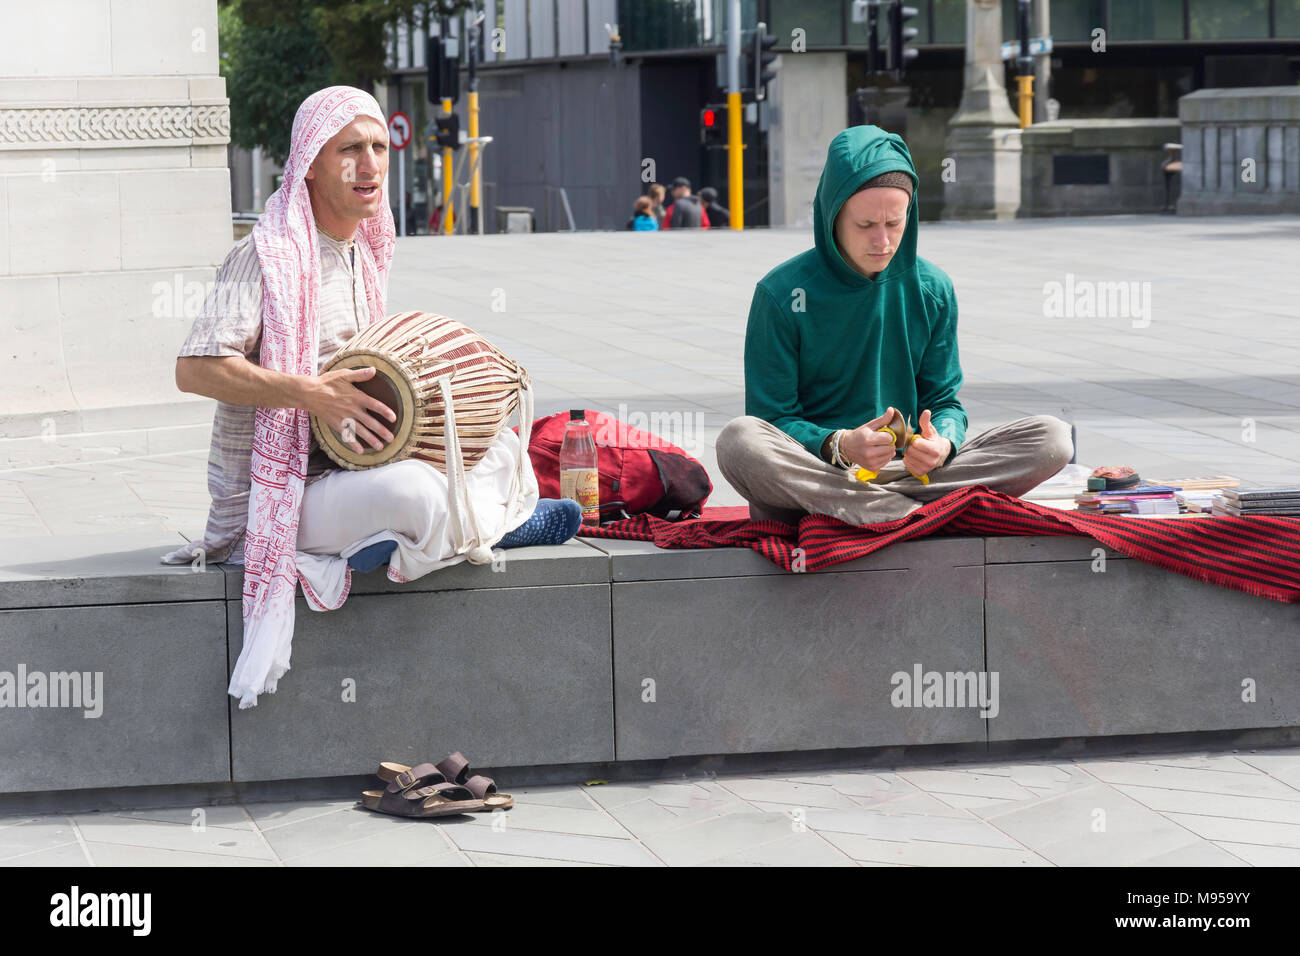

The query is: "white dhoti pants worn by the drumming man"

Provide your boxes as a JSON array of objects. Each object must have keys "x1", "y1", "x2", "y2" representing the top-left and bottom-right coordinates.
[{"x1": 295, "y1": 429, "x2": 538, "y2": 611}]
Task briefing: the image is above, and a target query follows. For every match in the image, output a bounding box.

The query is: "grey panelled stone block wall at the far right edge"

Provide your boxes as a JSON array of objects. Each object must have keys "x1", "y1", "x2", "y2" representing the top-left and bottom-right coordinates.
[{"x1": 1178, "y1": 86, "x2": 1300, "y2": 216}]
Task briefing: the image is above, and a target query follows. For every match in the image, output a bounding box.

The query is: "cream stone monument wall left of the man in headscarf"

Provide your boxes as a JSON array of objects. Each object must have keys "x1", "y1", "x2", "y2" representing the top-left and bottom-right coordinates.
[{"x1": 0, "y1": 0, "x2": 231, "y2": 447}]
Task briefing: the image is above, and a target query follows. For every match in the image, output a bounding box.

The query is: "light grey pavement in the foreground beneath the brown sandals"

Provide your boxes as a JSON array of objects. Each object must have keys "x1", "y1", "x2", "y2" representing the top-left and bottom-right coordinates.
[{"x1": 0, "y1": 748, "x2": 1300, "y2": 866}]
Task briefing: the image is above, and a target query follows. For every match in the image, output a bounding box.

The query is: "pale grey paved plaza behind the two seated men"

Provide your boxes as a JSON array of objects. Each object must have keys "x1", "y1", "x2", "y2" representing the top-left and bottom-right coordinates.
[{"x1": 0, "y1": 216, "x2": 1300, "y2": 546}]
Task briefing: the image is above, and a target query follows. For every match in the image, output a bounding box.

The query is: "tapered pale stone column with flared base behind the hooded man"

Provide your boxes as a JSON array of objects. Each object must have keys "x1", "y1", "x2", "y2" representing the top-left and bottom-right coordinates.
[{"x1": 943, "y1": 0, "x2": 1021, "y2": 219}]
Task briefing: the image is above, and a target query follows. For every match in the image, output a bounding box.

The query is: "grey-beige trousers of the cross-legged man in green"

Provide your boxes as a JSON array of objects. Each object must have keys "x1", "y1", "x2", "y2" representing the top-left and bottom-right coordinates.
[{"x1": 716, "y1": 415, "x2": 1073, "y2": 524}]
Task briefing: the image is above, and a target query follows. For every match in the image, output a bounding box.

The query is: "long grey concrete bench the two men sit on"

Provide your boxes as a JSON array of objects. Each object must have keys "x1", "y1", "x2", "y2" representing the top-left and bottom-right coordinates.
[{"x1": 0, "y1": 535, "x2": 1300, "y2": 795}]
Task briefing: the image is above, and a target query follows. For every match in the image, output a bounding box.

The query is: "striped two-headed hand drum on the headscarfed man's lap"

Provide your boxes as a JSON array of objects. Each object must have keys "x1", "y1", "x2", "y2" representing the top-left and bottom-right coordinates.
[{"x1": 311, "y1": 312, "x2": 533, "y2": 564}]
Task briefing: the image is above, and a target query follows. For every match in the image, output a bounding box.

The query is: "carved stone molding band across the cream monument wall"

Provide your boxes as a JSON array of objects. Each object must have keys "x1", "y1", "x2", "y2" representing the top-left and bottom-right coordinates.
[{"x1": 0, "y1": 103, "x2": 230, "y2": 150}]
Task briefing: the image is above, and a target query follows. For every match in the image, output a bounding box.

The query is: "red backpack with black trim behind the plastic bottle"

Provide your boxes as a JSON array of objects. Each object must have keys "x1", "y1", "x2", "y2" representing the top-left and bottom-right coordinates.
[{"x1": 528, "y1": 411, "x2": 714, "y2": 524}]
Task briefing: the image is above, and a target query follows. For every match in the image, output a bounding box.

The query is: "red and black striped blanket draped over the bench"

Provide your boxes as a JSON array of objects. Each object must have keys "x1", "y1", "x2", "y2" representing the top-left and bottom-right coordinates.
[{"x1": 579, "y1": 485, "x2": 1300, "y2": 604}]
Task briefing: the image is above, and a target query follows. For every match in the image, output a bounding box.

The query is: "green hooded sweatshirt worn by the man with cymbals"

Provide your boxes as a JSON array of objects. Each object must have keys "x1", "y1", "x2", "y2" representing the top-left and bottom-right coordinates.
[{"x1": 745, "y1": 126, "x2": 966, "y2": 464}]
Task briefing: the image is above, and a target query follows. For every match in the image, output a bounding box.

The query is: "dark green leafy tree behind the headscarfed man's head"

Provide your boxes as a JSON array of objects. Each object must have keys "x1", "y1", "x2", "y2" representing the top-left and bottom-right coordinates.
[{"x1": 218, "y1": 0, "x2": 469, "y2": 165}]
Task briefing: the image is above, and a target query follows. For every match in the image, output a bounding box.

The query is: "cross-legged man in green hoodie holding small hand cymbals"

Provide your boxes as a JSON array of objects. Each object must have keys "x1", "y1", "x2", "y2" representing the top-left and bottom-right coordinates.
[{"x1": 716, "y1": 126, "x2": 1073, "y2": 524}]
